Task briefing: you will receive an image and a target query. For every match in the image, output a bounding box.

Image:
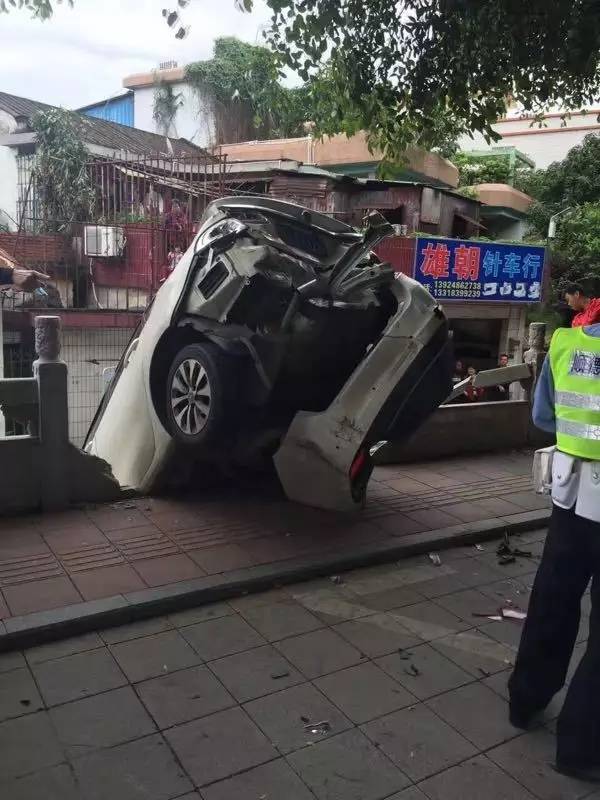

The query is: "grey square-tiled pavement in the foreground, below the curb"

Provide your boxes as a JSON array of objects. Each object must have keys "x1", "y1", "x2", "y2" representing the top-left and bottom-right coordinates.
[{"x1": 0, "y1": 532, "x2": 600, "y2": 800}]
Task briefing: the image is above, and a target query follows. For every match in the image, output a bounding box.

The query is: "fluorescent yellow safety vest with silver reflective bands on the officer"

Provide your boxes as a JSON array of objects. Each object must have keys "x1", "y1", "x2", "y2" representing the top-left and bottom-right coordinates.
[{"x1": 548, "y1": 328, "x2": 600, "y2": 461}]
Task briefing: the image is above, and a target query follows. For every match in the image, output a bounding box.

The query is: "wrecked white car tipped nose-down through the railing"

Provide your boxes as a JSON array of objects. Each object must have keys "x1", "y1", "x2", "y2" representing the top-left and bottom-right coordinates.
[{"x1": 85, "y1": 197, "x2": 452, "y2": 510}]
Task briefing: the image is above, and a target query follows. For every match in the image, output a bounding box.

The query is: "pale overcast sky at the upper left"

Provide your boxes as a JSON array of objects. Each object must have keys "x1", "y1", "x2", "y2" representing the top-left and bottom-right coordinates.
[{"x1": 0, "y1": 0, "x2": 269, "y2": 108}]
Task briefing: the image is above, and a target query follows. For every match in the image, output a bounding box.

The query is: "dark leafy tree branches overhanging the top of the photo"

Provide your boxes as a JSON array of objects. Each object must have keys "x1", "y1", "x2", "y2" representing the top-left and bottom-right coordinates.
[{"x1": 8, "y1": 0, "x2": 600, "y2": 161}]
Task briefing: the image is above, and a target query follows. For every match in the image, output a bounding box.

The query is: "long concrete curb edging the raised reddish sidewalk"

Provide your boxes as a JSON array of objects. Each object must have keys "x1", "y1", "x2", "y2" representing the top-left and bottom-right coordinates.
[{"x1": 0, "y1": 510, "x2": 550, "y2": 652}]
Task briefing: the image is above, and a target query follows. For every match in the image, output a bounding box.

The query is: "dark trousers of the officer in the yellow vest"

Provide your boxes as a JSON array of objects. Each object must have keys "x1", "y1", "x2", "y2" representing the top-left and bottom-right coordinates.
[{"x1": 509, "y1": 506, "x2": 600, "y2": 766}]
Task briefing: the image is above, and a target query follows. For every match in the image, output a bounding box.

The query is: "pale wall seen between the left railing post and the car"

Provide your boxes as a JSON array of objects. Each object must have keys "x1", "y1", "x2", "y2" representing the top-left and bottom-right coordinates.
[{"x1": 61, "y1": 328, "x2": 133, "y2": 447}]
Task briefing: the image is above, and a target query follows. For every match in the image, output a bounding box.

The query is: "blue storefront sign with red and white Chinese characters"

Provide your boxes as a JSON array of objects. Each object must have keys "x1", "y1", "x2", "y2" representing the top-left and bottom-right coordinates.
[{"x1": 414, "y1": 237, "x2": 545, "y2": 303}]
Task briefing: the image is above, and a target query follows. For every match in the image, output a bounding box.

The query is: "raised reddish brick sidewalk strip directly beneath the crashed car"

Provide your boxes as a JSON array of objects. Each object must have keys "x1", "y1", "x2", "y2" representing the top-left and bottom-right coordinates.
[{"x1": 0, "y1": 453, "x2": 547, "y2": 624}]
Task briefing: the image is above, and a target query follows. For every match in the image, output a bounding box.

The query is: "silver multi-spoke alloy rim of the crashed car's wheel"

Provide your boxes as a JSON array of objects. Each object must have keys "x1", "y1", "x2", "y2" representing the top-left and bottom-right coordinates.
[{"x1": 171, "y1": 358, "x2": 212, "y2": 436}]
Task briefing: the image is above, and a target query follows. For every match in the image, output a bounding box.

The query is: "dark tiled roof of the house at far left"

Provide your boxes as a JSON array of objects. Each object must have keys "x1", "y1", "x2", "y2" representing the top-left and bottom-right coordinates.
[{"x1": 0, "y1": 92, "x2": 206, "y2": 156}]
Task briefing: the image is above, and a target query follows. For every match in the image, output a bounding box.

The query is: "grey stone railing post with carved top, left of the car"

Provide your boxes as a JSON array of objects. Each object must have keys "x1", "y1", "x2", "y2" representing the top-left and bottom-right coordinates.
[{"x1": 33, "y1": 316, "x2": 69, "y2": 510}]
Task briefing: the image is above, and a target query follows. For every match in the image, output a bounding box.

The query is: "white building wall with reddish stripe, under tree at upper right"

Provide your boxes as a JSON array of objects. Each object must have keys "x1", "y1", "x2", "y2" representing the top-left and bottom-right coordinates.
[{"x1": 459, "y1": 111, "x2": 600, "y2": 168}]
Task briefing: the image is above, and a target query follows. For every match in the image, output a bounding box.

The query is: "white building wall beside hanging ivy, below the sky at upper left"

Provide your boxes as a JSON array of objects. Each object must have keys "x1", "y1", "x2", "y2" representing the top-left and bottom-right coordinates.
[{"x1": 133, "y1": 83, "x2": 214, "y2": 147}]
